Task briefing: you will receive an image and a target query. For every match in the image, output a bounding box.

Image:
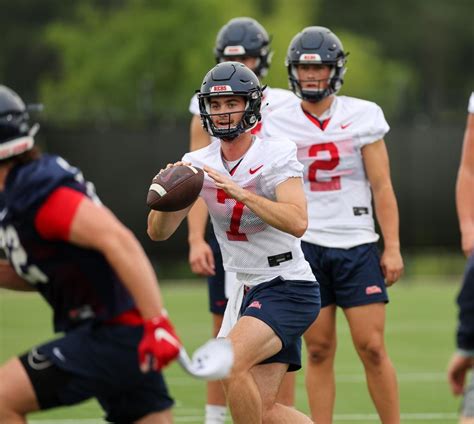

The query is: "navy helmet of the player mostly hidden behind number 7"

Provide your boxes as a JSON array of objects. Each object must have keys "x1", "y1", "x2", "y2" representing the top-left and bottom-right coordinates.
[{"x1": 214, "y1": 17, "x2": 272, "y2": 77}]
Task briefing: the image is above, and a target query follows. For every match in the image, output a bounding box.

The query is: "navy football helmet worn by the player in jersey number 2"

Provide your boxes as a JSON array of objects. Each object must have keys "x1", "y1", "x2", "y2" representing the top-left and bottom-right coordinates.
[{"x1": 285, "y1": 26, "x2": 347, "y2": 102}]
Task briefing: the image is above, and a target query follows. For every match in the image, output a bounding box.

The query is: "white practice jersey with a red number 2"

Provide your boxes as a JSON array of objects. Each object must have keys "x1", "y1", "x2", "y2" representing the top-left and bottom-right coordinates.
[{"x1": 262, "y1": 96, "x2": 389, "y2": 248}]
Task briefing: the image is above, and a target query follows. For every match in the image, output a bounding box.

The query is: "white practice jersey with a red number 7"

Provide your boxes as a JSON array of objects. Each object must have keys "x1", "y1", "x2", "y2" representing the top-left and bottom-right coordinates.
[{"x1": 183, "y1": 137, "x2": 314, "y2": 285}]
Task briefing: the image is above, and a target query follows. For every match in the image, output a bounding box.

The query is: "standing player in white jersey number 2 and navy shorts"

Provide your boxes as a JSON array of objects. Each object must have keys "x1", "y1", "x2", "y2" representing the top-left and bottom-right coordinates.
[{"x1": 262, "y1": 27, "x2": 403, "y2": 424}]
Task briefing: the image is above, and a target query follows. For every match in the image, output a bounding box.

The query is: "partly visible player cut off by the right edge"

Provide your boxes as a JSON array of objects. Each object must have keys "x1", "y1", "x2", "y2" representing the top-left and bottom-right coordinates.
[{"x1": 448, "y1": 92, "x2": 474, "y2": 424}]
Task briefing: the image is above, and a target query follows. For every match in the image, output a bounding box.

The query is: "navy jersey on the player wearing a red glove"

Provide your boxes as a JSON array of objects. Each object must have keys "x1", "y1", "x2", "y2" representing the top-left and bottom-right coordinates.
[{"x1": 0, "y1": 155, "x2": 134, "y2": 331}]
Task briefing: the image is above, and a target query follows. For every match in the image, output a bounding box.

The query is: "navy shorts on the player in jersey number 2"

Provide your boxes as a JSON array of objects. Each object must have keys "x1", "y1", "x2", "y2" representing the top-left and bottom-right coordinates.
[{"x1": 301, "y1": 242, "x2": 388, "y2": 308}]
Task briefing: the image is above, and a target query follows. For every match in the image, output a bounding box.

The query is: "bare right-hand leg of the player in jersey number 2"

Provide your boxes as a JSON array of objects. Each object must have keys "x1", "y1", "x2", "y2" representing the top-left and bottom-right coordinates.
[{"x1": 344, "y1": 303, "x2": 400, "y2": 424}]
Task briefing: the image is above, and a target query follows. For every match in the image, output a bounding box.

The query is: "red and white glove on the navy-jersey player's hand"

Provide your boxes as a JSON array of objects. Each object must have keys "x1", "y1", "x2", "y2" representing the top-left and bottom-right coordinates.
[{"x1": 138, "y1": 313, "x2": 181, "y2": 372}]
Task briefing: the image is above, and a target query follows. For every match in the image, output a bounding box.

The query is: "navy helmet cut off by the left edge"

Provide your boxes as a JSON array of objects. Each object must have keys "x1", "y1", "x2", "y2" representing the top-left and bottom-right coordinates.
[{"x1": 0, "y1": 85, "x2": 39, "y2": 160}]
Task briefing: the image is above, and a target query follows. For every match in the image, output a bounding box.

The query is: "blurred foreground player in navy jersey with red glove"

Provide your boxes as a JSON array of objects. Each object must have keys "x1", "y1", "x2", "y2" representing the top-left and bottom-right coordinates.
[{"x1": 0, "y1": 86, "x2": 180, "y2": 423}]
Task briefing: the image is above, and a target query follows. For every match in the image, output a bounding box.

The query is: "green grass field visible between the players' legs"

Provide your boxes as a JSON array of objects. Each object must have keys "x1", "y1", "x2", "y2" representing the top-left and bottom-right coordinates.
[{"x1": 0, "y1": 277, "x2": 466, "y2": 424}]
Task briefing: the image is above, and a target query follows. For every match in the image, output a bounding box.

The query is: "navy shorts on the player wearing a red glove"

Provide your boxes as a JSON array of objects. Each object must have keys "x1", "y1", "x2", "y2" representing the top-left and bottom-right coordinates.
[{"x1": 20, "y1": 324, "x2": 174, "y2": 423}]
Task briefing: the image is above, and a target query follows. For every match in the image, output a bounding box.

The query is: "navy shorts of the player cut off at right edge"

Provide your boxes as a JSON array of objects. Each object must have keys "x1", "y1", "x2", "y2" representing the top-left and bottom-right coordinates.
[{"x1": 457, "y1": 254, "x2": 474, "y2": 351}]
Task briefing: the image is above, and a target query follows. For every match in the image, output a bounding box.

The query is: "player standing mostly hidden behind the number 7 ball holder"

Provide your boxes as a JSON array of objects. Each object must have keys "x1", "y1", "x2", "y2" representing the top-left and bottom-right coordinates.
[{"x1": 188, "y1": 17, "x2": 298, "y2": 424}]
